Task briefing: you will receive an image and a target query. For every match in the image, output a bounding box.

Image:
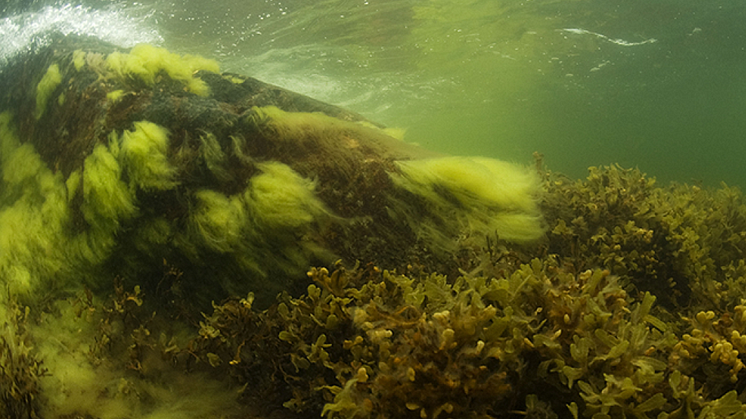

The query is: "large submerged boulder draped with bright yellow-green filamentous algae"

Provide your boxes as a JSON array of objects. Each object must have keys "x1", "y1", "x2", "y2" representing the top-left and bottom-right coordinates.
[{"x1": 0, "y1": 33, "x2": 544, "y2": 304}]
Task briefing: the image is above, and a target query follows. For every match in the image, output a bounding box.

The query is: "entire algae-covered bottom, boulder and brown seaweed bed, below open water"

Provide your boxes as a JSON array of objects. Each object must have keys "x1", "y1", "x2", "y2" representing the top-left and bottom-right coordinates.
[{"x1": 0, "y1": 32, "x2": 746, "y2": 419}]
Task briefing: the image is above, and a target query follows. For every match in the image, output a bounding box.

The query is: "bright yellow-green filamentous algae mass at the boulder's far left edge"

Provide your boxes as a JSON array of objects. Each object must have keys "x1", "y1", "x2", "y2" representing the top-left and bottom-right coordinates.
[{"x1": 0, "y1": 112, "x2": 179, "y2": 293}]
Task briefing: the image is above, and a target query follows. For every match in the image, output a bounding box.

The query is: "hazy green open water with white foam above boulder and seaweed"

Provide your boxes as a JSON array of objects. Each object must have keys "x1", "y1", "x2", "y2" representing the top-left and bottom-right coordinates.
[{"x1": 0, "y1": 0, "x2": 746, "y2": 187}]
